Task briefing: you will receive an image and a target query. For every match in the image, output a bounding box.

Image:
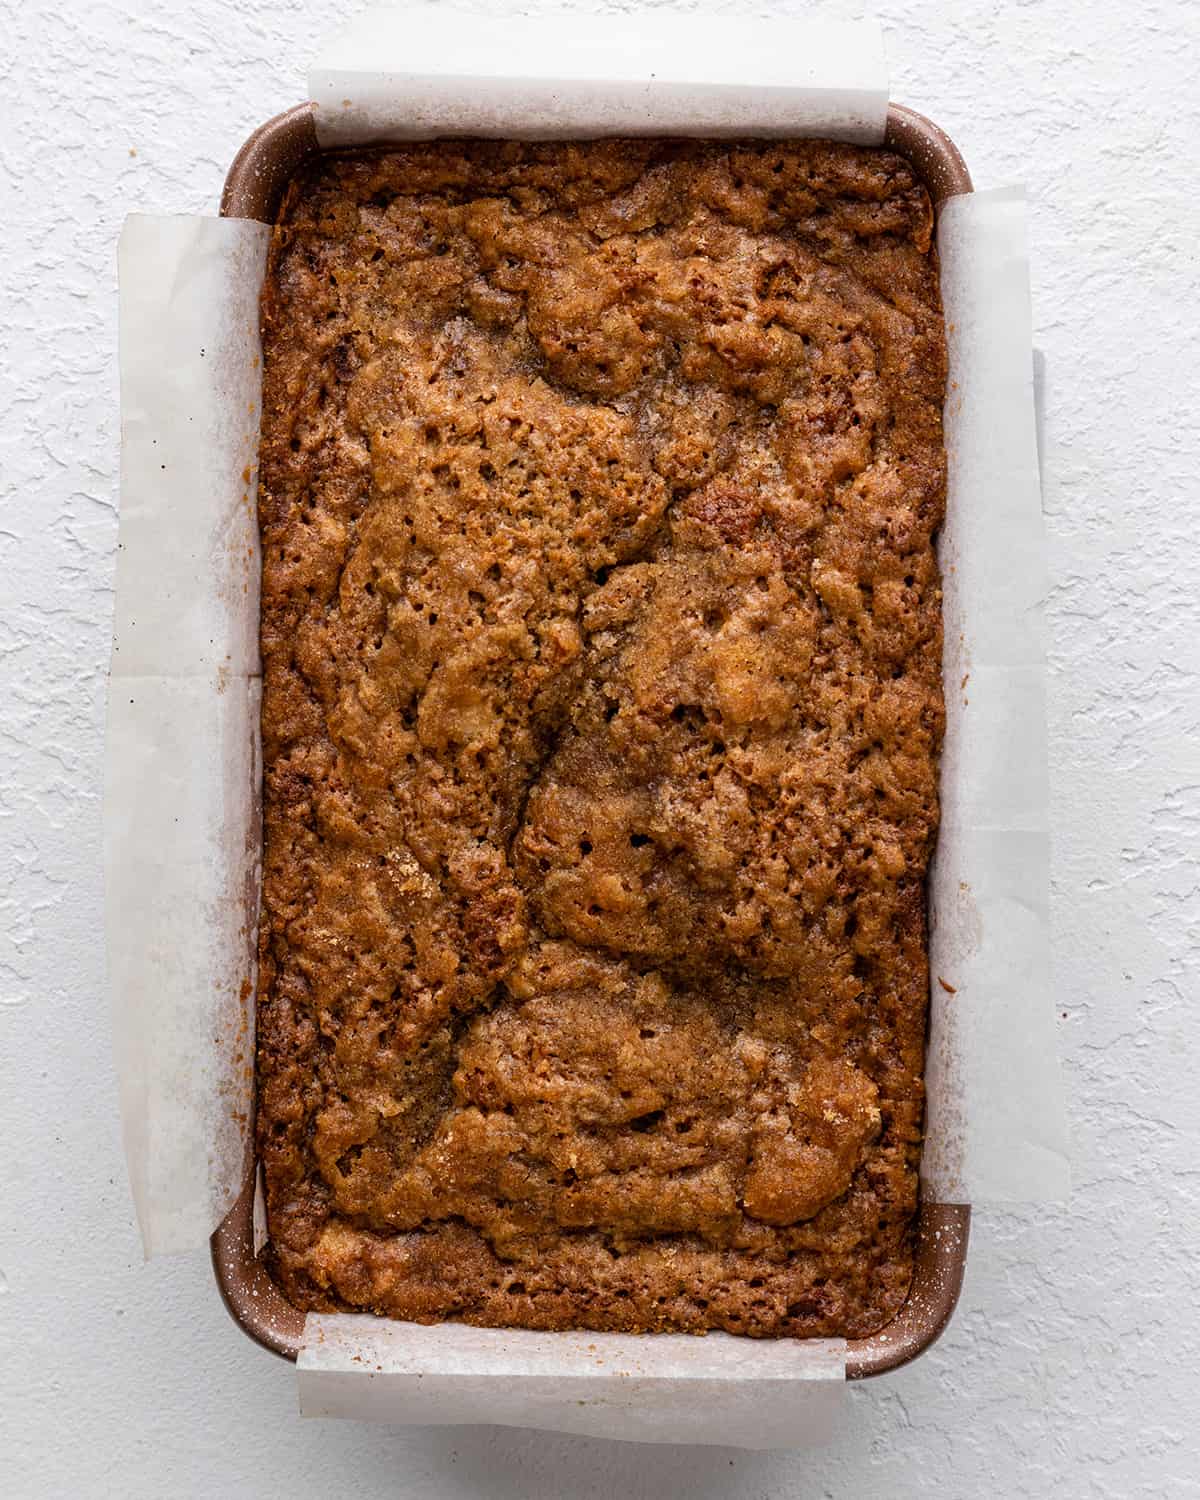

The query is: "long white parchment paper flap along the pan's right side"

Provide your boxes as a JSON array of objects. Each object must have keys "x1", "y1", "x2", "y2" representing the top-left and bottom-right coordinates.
[{"x1": 923, "y1": 188, "x2": 1070, "y2": 1203}]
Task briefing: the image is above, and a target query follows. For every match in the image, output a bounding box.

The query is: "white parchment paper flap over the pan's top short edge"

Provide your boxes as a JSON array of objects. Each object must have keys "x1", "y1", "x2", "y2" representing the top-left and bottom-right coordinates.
[{"x1": 309, "y1": 5, "x2": 888, "y2": 146}]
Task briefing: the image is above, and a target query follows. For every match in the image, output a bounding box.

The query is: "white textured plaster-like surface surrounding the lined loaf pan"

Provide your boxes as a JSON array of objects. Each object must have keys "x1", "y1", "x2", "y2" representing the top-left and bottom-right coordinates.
[{"x1": 0, "y1": 0, "x2": 1200, "y2": 1500}]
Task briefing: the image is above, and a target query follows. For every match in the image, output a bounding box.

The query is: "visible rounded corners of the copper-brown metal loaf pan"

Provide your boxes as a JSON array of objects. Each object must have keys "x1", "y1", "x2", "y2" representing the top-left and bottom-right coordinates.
[{"x1": 212, "y1": 104, "x2": 971, "y2": 1380}]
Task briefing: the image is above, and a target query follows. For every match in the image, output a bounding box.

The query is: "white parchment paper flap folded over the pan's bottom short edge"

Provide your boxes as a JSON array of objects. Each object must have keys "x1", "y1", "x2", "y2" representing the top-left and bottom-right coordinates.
[{"x1": 300, "y1": 1314, "x2": 846, "y2": 1448}]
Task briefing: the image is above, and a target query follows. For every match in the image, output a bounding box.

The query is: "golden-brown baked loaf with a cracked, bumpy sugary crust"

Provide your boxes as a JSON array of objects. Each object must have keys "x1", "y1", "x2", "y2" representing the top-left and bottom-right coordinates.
[{"x1": 258, "y1": 143, "x2": 945, "y2": 1337}]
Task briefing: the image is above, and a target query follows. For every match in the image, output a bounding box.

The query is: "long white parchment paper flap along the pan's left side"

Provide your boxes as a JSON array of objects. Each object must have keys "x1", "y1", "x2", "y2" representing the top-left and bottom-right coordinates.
[{"x1": 104, "y1": 215, "x2": 270, "y2": 1256}]
